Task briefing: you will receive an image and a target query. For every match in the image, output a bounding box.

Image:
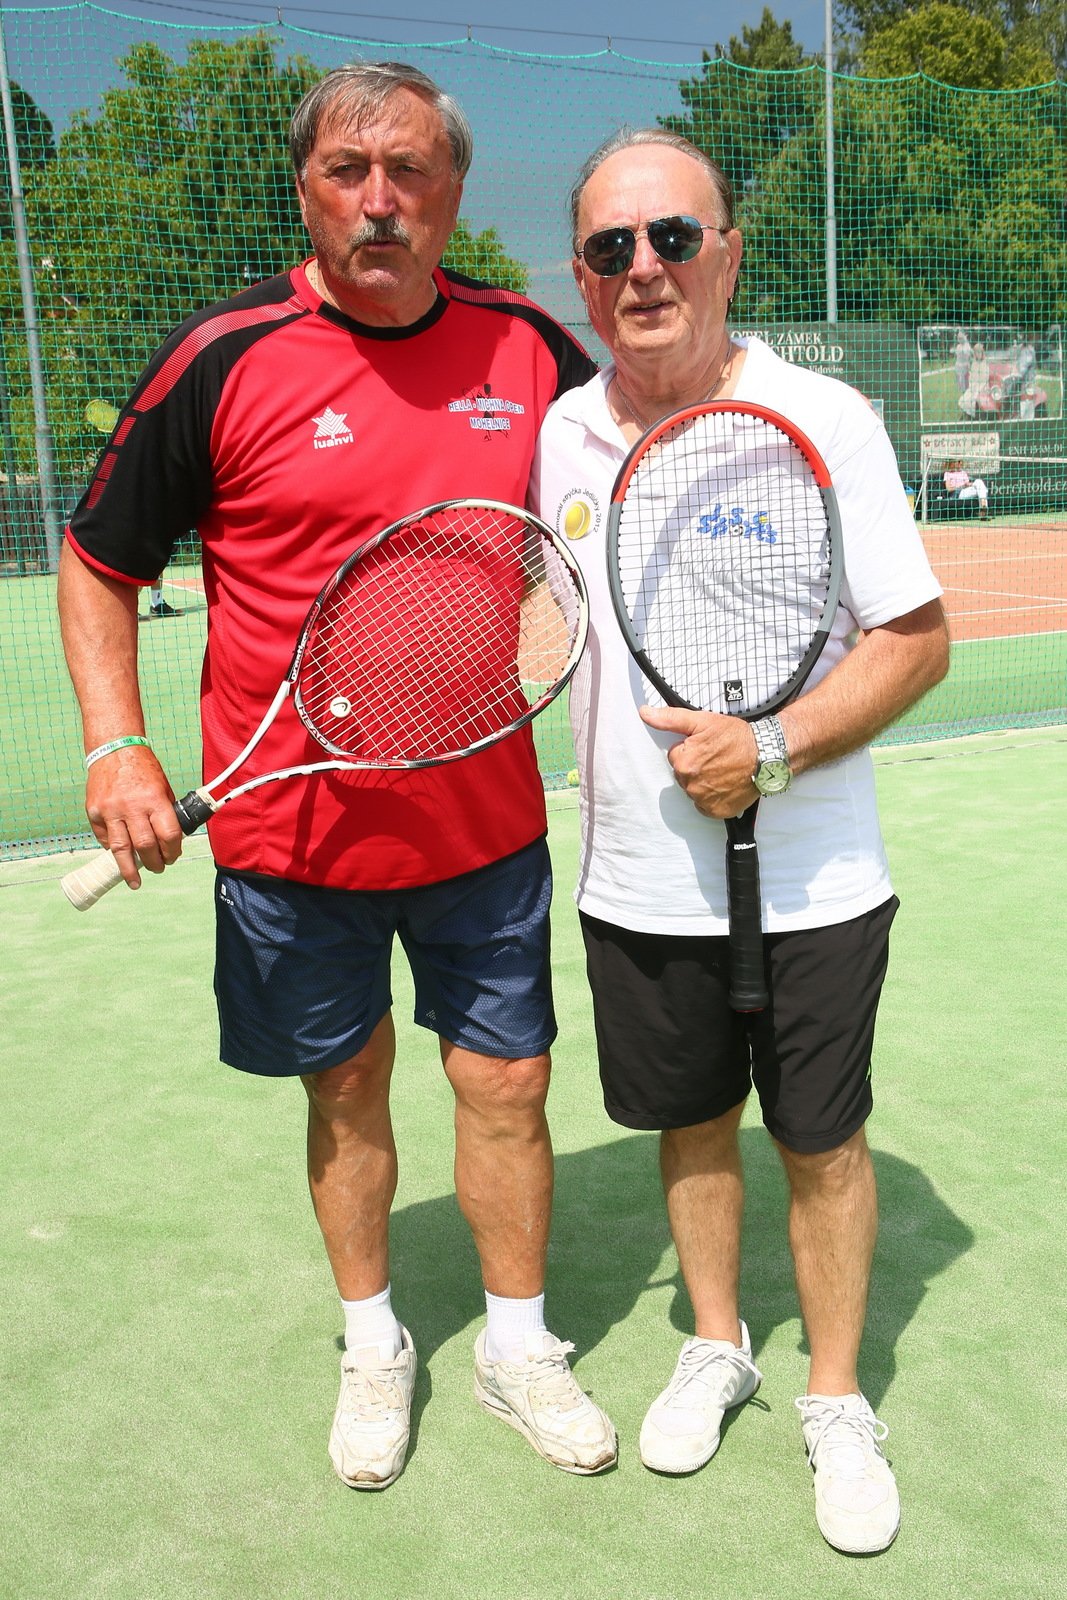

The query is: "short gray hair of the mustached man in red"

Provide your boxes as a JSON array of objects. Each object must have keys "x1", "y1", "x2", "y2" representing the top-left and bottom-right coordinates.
[{"x1": 290, "y1": 61, "x2": 474, "y2": 181}]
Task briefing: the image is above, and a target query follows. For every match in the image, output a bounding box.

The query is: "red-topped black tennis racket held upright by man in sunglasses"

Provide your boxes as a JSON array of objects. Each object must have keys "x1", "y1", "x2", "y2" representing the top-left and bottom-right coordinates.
[{"x1": 608, "y1": 400, "x2": 841, "y2": 1011}]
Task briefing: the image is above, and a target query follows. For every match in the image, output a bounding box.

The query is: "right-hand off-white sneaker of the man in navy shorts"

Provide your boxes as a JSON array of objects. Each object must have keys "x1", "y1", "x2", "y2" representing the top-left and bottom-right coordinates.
[{"x1": 474, "y1": 1333, "x2": 617, "y2": 1472}]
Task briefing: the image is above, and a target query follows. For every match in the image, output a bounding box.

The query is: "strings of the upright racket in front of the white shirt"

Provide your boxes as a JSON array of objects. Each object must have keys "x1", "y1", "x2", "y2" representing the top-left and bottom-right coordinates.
[{"x1": 617, "y1": 411, "x2": 830, "y2": 714}]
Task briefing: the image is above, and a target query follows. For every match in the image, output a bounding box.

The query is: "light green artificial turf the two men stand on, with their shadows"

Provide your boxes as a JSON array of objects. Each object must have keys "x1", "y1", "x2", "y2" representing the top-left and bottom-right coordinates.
[{"x1": 0, "y1": 730, "x2": 1067, "y2": 1600}]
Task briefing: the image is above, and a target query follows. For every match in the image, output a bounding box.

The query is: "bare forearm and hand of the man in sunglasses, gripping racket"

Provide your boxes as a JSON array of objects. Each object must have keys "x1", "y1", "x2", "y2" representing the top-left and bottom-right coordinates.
[{"x1": 641, "y1": 600, "x2": 949, "y2": 818}]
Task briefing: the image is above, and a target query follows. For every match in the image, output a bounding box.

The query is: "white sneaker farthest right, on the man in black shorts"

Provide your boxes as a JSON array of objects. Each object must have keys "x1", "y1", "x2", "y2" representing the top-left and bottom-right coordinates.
[{"x1": 797, "y1": 1395, "x2": 901, "y2": 1555}]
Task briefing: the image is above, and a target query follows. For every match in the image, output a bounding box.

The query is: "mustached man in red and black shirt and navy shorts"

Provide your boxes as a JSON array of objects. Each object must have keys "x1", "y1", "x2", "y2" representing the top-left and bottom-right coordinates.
[{"x1": 61, "y1": 62, "x2": 616, "y2": 1490}]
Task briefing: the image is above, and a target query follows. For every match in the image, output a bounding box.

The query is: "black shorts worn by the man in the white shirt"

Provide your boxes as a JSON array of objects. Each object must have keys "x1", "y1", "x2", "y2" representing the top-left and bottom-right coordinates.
[{"x1": 581, "y1": 896, "x2": 897, "y2": 1154}]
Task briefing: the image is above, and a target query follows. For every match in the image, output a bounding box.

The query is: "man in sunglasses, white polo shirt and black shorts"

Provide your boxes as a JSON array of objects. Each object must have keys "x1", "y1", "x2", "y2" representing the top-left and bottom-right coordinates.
[{"x1": 531, "y1": 130, "x2": 947, "y2": 1552}]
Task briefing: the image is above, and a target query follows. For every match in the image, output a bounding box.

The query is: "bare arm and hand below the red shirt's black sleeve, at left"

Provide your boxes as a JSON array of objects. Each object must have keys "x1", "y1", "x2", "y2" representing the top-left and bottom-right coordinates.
[{"x1": 59, "y1": 544, "x2": 182, "y2": 888}]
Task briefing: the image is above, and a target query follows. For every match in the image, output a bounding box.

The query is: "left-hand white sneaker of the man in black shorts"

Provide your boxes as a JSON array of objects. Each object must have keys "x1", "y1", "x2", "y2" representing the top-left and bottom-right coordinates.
[{"x1": 640, "y1": 1323, "x2": 763, "y2": 1472}]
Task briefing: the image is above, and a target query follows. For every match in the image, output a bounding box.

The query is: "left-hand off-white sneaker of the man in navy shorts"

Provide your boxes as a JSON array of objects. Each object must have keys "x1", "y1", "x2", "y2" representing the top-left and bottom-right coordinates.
[{"x1": 330, "y1": 1328, "x2": 414, "y2": 1490}]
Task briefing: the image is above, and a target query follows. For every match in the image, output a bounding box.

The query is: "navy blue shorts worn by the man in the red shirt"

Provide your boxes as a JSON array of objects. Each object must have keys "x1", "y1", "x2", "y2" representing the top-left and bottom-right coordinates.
[{"x1": 214, "y1": 838, "x2": 555, "y2": 1077}]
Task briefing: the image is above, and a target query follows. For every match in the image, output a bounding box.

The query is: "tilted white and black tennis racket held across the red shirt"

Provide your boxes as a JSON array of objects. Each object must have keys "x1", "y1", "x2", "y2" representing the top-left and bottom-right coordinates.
[{"x1": 62, "y1": 501, "x2": 589, "y2": 910}]
